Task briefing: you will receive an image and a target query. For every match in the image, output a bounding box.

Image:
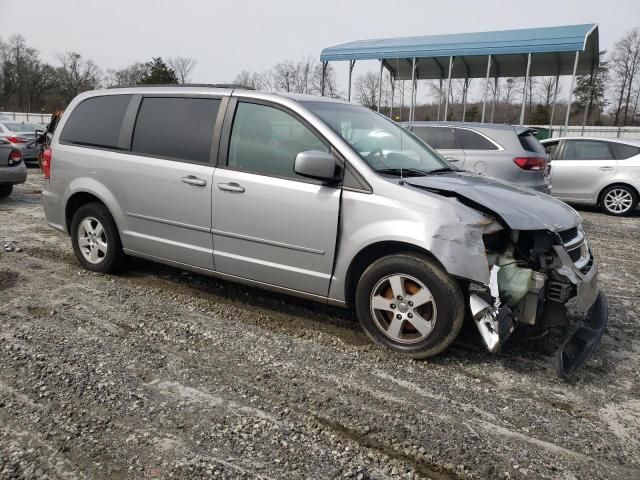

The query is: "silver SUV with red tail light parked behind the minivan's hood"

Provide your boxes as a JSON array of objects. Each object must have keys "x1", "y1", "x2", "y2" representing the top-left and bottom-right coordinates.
[{"x1": 403, "y1": 122, "x2": 550, "y2": 193}]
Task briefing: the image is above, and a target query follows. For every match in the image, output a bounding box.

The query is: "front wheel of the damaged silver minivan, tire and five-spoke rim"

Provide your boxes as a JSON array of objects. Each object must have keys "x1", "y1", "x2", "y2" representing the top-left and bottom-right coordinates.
[{"x1": 355, "y1": 253, "x2": 465, "y2": 359}]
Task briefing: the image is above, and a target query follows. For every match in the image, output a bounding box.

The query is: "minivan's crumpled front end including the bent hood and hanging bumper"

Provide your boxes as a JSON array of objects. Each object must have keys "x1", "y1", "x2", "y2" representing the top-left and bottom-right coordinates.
[{"x1": 412, "y1": 173, "x2": 608, "y2": 378}]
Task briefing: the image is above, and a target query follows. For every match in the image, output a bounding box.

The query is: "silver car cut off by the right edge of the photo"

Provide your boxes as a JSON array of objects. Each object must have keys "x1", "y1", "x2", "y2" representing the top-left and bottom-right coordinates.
[{"x1": 542, "y1": 137, "x2": 640, "y2": 215}]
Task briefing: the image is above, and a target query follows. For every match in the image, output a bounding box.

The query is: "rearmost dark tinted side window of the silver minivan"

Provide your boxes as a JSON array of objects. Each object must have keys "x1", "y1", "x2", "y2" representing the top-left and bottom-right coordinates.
[{"x1": 60, "y1": 95, "x2": 132, "y2": 150}]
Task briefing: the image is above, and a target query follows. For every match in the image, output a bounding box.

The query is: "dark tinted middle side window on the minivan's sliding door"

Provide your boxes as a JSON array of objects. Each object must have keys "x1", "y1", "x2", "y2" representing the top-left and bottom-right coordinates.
[{"x1": 131, "y1": 97, "x2": 220, "y2": 163}]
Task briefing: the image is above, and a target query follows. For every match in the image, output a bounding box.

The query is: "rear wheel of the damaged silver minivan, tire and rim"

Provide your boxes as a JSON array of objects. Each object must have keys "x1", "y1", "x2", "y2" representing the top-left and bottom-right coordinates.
[{"x1": 70, "y1": 203, "x2": 126, "y2": 273}]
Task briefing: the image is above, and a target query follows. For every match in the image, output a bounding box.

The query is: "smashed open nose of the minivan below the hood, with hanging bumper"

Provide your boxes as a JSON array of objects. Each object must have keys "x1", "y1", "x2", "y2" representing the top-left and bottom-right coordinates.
[{"x1": 469, "y1": 226, "x2": 607, "y2": 378}]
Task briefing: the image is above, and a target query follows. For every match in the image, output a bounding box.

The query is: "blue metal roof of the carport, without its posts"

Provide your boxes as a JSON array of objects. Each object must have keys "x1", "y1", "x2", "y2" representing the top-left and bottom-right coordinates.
[{"x1": 320, "y1": 23, "x2": 598, "y2": 80}]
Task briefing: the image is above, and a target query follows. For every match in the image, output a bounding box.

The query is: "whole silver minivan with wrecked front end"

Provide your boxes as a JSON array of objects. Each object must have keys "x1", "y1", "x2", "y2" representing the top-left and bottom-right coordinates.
[{"x1": 42, "y1": 86, "x2": 607, "y2": 376}]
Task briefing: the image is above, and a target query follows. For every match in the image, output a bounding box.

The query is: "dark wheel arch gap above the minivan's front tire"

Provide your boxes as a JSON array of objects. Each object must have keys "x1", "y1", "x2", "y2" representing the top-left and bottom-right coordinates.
[{"x1": 344, "y1": 240, "x2": 448, "y2": 305}]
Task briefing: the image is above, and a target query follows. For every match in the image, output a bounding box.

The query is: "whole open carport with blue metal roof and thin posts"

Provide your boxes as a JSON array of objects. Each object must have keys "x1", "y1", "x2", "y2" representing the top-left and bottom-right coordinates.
[{"x1": 320, "y1": 24, "x2": 599, "y2": 127}]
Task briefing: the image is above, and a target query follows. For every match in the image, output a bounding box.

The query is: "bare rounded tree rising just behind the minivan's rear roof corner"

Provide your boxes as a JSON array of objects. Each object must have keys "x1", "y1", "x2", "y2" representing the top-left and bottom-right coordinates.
[{"x1": 56, "y1": 52, "x2": 101, "y2": 103}]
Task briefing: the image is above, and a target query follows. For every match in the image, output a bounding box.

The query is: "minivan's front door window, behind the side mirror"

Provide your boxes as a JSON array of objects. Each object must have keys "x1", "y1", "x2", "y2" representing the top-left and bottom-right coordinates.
[{"x1": 227, "y1": 102, "x2": 329, "y2": 181}]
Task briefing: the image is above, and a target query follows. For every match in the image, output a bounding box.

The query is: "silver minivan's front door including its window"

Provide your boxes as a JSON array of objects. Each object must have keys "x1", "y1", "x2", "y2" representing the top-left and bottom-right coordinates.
[{"x1": 213, "y1": 101, "x2": 341, "y2": 296}]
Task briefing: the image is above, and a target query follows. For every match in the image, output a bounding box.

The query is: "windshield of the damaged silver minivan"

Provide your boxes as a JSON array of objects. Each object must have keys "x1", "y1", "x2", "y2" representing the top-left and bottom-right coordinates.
[{"x1": 302, "y1": 101, "x2": 455, "y2": 176}]
